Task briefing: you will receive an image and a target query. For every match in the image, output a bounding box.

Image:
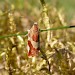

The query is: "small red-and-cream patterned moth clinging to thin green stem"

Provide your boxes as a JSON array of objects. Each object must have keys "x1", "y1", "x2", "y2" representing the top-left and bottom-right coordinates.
[{"x1": 28, "y1": 22, "x2": 39, "y2": 57}]
